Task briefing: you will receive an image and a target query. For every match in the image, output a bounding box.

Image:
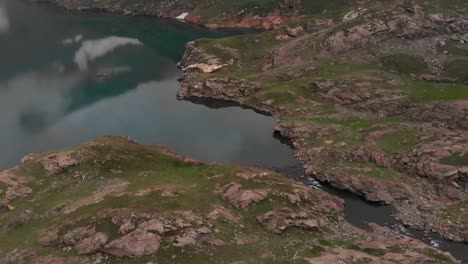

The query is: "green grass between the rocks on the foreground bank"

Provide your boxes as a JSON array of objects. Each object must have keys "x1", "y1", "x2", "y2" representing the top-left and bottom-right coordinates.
[{"x1": 0, "y1": 138, "x2": 450, "y2": 263}]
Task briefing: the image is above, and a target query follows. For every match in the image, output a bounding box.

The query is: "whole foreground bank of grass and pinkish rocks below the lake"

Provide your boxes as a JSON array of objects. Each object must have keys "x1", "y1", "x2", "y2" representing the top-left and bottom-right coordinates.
[{"x1": 0, "y1": 137, "x2": 456, "y2": 264}]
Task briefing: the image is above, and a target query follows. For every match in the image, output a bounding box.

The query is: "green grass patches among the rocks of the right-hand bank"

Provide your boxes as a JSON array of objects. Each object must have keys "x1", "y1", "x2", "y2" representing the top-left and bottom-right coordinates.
[{"x1": 180, "y1": 0, "x2": 468, "y2": 237}]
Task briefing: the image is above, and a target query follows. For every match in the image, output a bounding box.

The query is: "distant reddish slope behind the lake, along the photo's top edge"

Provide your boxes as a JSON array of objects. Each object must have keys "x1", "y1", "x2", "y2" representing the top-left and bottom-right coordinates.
[{"x1": 40, "y1": 0, "x2": 359, "y2": 29}]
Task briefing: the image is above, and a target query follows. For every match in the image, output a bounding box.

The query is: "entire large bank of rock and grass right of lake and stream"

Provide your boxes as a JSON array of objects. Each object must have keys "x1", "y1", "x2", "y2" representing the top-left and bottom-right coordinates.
[{"x1": 178, "y1": 1, "x2": 468, "y2": 242}]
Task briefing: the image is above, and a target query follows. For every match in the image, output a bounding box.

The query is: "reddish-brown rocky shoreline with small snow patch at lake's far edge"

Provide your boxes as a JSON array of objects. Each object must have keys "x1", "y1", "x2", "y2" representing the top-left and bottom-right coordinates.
[{"x1": 34, "y1": 0, "x2": 301, "y2": 29}]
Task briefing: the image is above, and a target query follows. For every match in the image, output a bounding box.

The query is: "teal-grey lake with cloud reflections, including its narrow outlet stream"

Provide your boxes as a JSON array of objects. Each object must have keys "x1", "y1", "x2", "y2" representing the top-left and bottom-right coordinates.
[{"x1": 0, "y1": 0, "x2": 468, "y2": 261}]
